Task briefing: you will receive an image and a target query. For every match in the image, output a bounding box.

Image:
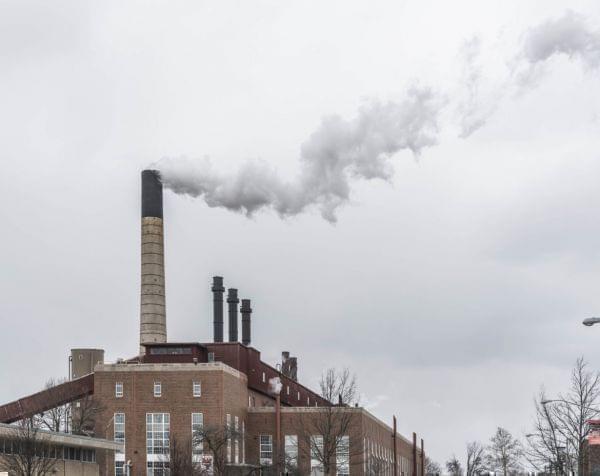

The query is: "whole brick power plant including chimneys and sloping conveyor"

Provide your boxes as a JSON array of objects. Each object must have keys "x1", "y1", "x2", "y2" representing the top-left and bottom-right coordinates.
[{"x1": 0, "y1": 170, "x2": 424, "y2": 476}]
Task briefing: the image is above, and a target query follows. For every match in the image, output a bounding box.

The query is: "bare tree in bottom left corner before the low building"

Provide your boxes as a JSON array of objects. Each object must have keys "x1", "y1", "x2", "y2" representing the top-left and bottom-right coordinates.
[{"x1": 0, "y1": 418, "x2": 56, "y2": 476}]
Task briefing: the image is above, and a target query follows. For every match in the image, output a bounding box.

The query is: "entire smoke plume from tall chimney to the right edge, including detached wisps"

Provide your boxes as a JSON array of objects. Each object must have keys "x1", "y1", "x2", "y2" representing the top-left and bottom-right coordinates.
[{"x1": 153, "y1": 11, "x2": 600, "y2": 222}]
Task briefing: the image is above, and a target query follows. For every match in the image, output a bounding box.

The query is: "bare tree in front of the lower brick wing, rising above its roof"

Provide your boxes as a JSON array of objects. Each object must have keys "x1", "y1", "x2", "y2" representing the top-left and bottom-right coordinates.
[{"x1": 299, "y1": 368, "x2": 362, "y2": 476}]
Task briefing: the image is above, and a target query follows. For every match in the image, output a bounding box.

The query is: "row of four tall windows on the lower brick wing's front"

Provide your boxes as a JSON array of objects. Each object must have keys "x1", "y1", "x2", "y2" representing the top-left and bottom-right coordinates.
[{"x1": 259, "y1": 435, "x2": 350, "y2": 476}]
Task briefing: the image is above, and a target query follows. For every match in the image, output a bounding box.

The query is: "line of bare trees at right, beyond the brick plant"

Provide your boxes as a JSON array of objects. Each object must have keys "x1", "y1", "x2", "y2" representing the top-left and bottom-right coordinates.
[{"x1": 426, "y1": 357, "x2": 600, "y2": 476}]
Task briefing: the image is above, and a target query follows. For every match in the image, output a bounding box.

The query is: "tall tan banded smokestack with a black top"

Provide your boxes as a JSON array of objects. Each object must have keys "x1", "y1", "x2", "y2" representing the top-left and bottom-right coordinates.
[{"x1": 140, "y1": 170, "x2": 167, "y2": 353}]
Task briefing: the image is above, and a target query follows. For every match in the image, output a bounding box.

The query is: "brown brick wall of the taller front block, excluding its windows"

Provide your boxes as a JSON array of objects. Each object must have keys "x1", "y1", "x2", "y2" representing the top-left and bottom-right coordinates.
[{"x1": 94, "y1": 363, "x2": 248, "y2": 475}]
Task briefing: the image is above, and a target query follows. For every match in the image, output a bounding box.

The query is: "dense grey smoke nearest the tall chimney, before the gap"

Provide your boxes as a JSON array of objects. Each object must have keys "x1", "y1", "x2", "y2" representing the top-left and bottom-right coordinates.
[{"x1": 153, "y1": 87, "x2": 443, "y2": 222}]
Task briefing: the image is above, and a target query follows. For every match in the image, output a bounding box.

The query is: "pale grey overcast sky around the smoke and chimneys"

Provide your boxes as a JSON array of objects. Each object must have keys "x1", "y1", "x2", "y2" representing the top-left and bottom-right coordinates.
[{"x1": 0, "y1": 0, "x2": 600, "y2": 463}]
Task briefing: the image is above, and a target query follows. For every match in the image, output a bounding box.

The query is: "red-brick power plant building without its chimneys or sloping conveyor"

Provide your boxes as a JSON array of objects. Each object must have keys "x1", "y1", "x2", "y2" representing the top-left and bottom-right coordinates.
[{"x1": 93, "y1": 343, "x2": 424, "y2": 476}]
